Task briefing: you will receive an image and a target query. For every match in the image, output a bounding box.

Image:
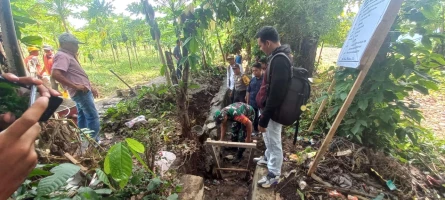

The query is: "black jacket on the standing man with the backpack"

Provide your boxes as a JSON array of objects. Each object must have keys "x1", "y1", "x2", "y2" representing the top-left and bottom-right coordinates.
[{"x1": 258, "y1": 45, "x2": 292, "y2": 128}]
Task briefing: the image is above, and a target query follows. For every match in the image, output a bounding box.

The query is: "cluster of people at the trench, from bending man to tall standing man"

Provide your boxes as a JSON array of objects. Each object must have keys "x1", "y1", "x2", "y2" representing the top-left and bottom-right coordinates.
[{"x1": 214, "y1": 26, "x2": 292, "y2": 188}]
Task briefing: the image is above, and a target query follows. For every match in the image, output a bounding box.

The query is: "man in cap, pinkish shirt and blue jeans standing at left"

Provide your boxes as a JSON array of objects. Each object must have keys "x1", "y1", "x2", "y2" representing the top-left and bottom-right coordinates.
[{"x1": 51, "y1": 33, "x2": 100, "y2": 141}]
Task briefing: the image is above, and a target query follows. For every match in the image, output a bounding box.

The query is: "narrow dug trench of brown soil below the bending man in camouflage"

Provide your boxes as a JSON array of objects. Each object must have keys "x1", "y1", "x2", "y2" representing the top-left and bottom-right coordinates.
[{"x1": 177, "y1": 76, "x2": 264, "y2": 200}]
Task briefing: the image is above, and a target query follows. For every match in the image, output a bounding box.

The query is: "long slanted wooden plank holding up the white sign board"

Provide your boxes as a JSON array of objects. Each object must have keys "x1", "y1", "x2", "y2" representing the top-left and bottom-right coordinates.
[{"x1": 308, "y1": 0, "x2": 403, "y2": 176}]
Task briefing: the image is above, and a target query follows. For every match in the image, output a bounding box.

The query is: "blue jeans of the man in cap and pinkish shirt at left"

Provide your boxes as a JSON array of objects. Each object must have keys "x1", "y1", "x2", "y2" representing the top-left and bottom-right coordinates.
[{"x1": 71, "y1": 91, "x2": 100, "y2": 141}]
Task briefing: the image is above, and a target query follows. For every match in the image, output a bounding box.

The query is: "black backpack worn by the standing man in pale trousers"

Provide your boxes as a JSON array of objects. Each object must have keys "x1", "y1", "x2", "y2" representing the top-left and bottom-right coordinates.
[{"x1": 267, "y1": 53, "x2": 311, "y2": 145}]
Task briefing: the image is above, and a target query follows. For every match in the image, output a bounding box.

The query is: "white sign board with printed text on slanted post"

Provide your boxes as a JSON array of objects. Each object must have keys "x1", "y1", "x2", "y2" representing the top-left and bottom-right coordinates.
[{"x1": 337, "y1": 0, "x2": 391, "y2": 68}]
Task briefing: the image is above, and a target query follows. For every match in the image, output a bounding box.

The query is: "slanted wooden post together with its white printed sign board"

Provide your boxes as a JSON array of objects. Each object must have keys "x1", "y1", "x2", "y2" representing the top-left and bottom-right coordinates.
[{"x1": 308, "y1": 0, "x2": 403, "y2": 176}]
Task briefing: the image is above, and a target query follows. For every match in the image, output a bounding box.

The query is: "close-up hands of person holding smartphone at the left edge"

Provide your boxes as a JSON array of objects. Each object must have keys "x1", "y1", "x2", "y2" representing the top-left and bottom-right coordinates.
[{"x1": 0, "y1": 73, "x2": 60, "y2": 199}]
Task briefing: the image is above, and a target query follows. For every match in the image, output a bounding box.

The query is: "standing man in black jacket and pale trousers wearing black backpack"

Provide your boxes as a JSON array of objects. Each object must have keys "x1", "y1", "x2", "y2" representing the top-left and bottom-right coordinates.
[{"x1": 256, "y1": 26, "x2": 310, "y2": 188}]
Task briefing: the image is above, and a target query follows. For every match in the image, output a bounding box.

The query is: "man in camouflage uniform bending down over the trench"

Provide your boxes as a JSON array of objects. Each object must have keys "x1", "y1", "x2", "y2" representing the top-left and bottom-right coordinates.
[{"x1": 213, "y1": 102, "x2": 255, "y2": 163}]
